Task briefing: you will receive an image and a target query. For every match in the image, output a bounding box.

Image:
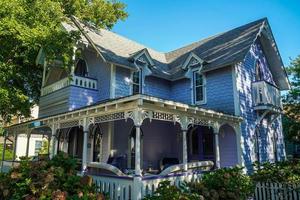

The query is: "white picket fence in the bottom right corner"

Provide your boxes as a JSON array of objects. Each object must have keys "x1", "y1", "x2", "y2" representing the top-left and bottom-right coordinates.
[{"x1": 254, "y1": 182, "x2": 300, "y2": 200}]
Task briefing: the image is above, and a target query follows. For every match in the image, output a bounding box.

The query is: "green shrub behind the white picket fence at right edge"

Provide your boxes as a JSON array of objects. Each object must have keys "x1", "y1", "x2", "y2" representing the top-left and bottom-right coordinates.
[{"x1": 252, "y1": 160, "x2": 300, "y2": 184}]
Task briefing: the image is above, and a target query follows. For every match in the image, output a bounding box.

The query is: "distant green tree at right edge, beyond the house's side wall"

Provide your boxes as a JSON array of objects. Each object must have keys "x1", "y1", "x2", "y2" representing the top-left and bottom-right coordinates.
[{"x1": 283, "y1": 56, "x2": 300, "y2": 143}]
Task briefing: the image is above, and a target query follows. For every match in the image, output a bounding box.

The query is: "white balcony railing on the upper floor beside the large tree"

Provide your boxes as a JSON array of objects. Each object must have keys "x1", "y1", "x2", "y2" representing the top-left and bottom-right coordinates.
[{"x1": 41, "y1": 76, "x2": 97, "y2": 96}]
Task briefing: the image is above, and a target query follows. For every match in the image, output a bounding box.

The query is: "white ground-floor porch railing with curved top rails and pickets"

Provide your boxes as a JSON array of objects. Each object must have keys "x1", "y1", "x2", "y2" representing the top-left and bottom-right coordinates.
[{"x1": 88, "y1": 161, "x2": 213, "y2": 200}]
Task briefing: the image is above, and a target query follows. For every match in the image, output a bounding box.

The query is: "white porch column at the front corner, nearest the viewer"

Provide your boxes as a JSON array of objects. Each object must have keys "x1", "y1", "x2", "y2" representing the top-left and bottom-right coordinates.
[{"x1": 135, "y1": 125, "x2": 142, "y2": 176}]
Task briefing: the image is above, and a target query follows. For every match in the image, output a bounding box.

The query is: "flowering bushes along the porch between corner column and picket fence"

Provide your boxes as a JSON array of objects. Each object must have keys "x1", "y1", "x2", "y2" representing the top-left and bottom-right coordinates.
[{"x1": 145, "y1": 167, "x2": 254, "y2": 200}]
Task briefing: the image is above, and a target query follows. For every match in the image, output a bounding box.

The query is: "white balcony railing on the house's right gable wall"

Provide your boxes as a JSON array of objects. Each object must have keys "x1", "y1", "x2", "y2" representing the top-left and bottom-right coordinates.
[{"x1": 252, "y1": 81, "x2": 282, "y2": 109}]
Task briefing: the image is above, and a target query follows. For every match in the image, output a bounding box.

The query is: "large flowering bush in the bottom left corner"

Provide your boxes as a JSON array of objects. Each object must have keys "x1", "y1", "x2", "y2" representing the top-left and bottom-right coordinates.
[{"x1": 0, "y1": 153, "x2": 105, "y2": 200}]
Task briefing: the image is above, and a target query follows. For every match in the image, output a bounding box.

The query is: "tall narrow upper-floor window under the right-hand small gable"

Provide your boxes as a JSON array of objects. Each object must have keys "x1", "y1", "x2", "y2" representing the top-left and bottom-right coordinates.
[{"x1": 194, "y1": 72, "x2": 205, "y2": 103}]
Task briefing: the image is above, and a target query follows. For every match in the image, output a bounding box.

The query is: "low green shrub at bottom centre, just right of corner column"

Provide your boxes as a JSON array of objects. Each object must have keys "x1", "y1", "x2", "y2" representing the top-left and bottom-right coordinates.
[{"x1": 144, "y1": 181, "x2": 203, "y2": 200}]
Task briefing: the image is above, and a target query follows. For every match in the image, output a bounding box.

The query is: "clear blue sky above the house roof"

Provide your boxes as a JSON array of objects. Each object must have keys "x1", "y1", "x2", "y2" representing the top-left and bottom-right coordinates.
[{"x1": 113, "y1": 0, "x2": 300, "y2": 66}]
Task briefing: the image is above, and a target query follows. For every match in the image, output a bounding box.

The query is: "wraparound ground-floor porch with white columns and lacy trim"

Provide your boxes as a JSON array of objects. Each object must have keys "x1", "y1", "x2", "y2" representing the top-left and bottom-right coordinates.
[{"x1": 2, "y1": 95, "x2": 241, "y2": 199}]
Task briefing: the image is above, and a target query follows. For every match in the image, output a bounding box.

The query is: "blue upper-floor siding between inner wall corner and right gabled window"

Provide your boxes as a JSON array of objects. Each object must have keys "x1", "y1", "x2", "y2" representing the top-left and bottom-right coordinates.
[{"x1": 171, "y1": 79, "x2": 192, "y2": 104}]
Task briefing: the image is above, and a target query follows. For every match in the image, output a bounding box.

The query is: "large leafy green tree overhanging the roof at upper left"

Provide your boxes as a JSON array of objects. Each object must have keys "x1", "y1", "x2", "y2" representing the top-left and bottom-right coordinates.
[{"x1": 0, "y1": 0, "x2": 127, "y2": 122}]
